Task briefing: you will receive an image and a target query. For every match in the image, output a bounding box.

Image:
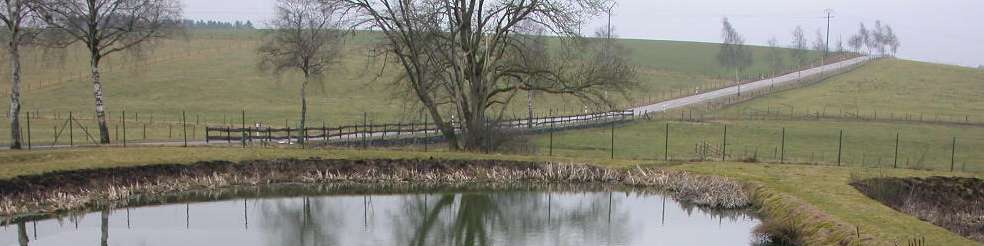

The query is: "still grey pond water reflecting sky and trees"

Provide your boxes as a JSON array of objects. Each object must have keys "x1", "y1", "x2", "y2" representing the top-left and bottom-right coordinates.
[{"x1": 0, "y1": 185, "x2": 760, "y2": 246}]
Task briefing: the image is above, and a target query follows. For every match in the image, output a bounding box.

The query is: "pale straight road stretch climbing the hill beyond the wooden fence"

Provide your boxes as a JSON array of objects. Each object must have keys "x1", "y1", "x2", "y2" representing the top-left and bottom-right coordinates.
[{"x1": 632, "y1": 56, "x2": 874, "y2": 115}]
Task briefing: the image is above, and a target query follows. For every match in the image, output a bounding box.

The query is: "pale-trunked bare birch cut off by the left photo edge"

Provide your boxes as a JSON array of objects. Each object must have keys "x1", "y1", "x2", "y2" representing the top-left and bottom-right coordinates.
[{"x1": 0, "y1": 0, "x2": 37, "y2": 149}]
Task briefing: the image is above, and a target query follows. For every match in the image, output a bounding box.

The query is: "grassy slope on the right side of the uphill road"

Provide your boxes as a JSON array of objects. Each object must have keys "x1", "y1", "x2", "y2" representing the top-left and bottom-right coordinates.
[{"x1": 718, "y1": 59, "x2": 984, "y2": 123}]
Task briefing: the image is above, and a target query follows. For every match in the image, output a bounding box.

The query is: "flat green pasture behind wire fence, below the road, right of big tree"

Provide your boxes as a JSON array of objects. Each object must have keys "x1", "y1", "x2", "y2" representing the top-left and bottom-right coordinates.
[{"x1": 534, "y1": 121, "x2": 984, "y2": 172}]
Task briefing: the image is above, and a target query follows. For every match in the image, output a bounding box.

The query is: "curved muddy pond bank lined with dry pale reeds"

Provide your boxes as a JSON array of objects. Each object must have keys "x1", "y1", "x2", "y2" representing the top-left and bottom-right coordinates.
[{"x1": 0, "y1": 159, "x2": 750, "y2": 218}]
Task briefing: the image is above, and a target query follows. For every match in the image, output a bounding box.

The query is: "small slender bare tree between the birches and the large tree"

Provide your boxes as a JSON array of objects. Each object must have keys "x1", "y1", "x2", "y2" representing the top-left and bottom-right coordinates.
[{"x1": 258, "y1": 0, "x2": 347, "y2": 143}]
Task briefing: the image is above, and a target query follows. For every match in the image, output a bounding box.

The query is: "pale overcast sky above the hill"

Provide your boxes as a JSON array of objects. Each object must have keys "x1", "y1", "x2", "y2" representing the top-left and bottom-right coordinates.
[{"x1": 181, "y1": 0, "x2": 984, "y2": 67}]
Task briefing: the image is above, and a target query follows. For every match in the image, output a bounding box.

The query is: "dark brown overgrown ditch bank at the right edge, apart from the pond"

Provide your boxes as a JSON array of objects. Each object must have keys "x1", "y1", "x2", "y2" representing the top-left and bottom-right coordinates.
[{"x1": 851, "y1": 177, "x2": 984, "y2": 243}]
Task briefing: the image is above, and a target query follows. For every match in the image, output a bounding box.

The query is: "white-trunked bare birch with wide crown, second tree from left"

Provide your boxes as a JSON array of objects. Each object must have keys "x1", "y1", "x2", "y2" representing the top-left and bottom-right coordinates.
[{"x1": 34, "y1": 0, "x2": 181, "y2": 144}]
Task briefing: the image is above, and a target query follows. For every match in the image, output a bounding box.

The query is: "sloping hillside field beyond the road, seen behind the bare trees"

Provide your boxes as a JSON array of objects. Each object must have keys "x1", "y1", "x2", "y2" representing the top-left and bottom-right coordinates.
[{"x1": 0, "y1": 30, "x2": 824, "y2": 144}]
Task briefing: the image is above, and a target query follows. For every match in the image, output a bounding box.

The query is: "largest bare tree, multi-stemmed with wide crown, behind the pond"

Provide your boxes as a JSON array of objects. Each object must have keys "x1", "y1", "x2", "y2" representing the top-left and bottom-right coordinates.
[{"x1": 332, "y1": 0, "x2": 635, "y2": 150}]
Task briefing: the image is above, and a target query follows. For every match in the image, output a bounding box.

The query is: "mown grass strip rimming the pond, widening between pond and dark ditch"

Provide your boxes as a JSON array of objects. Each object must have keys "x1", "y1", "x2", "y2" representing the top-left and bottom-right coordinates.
[{"x1": 0, "y1": 147, "x2": 981, "y2": 245}]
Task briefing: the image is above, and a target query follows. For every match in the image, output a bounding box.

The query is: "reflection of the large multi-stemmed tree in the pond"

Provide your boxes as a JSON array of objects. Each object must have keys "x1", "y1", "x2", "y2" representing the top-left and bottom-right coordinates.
[{"x1": 393, "y1": 192, "x2": 632, "y2": 246}]
